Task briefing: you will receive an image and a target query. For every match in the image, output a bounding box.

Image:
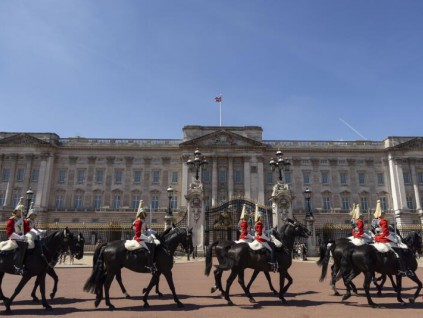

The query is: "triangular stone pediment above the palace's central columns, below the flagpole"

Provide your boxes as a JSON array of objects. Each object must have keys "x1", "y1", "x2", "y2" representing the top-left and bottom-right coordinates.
[{"x1": 180, "y1": 129, "x2": 266, "y2": 148}]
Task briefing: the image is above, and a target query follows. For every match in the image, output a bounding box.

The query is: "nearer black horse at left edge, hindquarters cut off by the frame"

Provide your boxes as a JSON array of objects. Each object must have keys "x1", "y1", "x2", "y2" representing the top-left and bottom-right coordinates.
[{"x1": 0, "y1": 228, "x2": 75, "y2": 314}]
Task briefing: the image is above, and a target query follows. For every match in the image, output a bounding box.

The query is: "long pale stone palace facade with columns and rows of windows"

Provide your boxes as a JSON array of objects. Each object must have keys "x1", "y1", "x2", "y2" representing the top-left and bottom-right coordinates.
[{"x1": 0, "y1": 126, "x2": 423, "y2": 226}]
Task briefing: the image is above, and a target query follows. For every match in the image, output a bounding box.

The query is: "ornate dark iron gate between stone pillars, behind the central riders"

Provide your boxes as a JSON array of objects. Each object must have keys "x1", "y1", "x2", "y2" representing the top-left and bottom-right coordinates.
[{"x1": 204, "y1": 199, "x2": 272, "y2": 246}]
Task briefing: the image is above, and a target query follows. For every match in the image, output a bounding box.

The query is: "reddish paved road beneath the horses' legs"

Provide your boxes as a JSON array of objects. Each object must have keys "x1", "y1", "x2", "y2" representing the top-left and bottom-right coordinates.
[{"x1": 2, "y1": 256, "x2": 423, "y2": 318}]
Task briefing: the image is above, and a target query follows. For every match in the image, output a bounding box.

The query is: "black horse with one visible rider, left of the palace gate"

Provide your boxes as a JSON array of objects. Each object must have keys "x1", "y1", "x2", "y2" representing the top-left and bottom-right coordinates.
[{"x1": 83, "y1": 228, "x2": 193, "y2": 310}]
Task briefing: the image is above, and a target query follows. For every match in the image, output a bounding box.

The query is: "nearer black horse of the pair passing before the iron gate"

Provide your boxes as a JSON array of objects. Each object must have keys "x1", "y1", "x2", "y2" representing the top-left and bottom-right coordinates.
[{"x1": 205, "y1": 219, "x2": 311, "y2": 305}]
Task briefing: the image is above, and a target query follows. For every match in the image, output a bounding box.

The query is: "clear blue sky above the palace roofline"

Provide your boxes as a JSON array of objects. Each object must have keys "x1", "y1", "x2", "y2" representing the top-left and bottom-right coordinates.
[{"x1": 0, "y1": 0, "x2": 423, "y2": 140}]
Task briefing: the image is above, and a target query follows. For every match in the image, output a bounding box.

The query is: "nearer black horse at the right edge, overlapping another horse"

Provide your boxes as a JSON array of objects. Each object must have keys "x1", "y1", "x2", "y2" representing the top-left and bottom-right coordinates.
[{"x1": 341, "y1": 233, "x2": 422, "y2": 307}]
